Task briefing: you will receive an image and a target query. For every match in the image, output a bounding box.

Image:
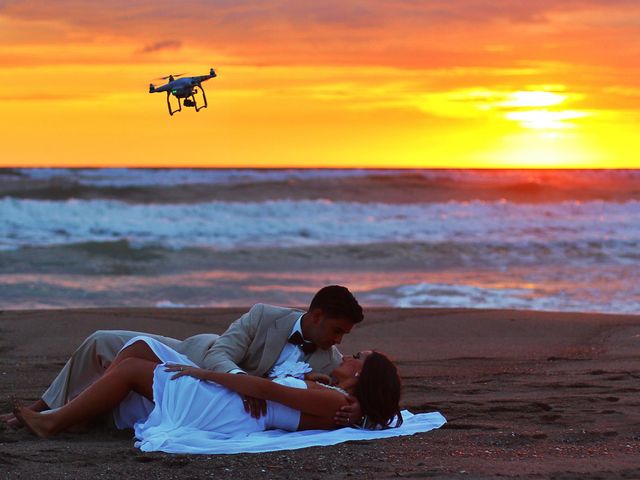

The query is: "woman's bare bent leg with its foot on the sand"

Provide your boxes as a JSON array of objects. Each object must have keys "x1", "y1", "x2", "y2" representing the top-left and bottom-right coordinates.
[{"x1": 15, "y1": 357, "x2": 158, "y2": 437}]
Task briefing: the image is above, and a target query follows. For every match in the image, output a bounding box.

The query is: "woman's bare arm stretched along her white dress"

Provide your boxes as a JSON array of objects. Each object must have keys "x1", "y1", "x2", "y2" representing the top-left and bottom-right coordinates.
[{"x1": 166, "y1": 365, "x2": 347, "y2": 418}]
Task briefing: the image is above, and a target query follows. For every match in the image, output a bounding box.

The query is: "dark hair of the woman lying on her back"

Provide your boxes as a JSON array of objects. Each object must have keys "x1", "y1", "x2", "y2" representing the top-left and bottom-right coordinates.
[{"x1": 355, "y1": 352, "x2": 402, "y2": 428}]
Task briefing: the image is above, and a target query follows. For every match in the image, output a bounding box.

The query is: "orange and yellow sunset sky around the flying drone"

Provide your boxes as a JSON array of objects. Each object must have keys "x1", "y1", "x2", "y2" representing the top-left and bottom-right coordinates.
[{"x1": 0, "y1": 0, "x2": 640, "y2": 168}]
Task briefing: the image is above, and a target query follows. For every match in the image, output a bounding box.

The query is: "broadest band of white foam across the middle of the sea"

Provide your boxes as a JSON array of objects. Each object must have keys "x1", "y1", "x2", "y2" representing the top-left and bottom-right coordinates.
[{"x1": 0, "y1": 198, "x2": 640, "y2": 263}]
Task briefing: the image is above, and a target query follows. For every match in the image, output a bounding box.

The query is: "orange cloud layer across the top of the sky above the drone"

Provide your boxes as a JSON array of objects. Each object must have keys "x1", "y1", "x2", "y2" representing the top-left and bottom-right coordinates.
[{"x1": 0, "y1": 0, "x2": 640, "y2": 69}]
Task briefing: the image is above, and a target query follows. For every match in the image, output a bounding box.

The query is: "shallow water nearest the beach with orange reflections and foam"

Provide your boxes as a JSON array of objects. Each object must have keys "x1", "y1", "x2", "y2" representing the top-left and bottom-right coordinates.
[{"x1": 0, "y1": 266, "x2": 640, "y2": 313}]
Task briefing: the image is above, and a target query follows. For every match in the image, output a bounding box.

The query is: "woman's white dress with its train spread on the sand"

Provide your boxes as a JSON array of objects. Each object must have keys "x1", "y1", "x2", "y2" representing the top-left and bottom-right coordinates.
[{"x1": 114, "y1": 337, "x2": 446, "y2": 454}]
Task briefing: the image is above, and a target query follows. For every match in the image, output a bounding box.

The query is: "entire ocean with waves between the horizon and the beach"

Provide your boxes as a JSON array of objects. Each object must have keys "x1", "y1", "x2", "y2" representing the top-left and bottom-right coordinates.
[{"x1": 0, "y1": 169, "x2": 640, "y2": 313}]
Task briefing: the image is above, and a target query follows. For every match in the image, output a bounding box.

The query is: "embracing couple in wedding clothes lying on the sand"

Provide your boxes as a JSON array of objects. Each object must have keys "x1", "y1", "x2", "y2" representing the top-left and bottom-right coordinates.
[{"x1": 3, "y1": 285, "x2": 402, "y2": 451}]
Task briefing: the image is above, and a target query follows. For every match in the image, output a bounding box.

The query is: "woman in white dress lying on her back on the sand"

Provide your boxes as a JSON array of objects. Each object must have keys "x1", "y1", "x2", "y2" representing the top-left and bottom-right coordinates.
[{"x1": 15, "y1": 337, "x2": 402, "y2": 451}]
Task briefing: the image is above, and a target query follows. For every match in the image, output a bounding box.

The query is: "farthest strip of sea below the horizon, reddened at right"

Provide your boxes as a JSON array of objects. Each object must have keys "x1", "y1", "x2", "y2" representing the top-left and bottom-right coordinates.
[{"x1": 0, "y1": 169, "x2": 640, "y2": 204}]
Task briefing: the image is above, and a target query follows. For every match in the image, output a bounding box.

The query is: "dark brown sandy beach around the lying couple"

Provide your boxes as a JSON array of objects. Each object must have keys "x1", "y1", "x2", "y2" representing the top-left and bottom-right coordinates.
[{"x1": 0, "y1": 308, "x2": 640, "y2": 480}]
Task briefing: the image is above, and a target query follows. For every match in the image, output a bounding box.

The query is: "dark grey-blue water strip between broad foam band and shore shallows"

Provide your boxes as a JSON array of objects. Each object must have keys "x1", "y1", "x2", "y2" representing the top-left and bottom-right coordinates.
[{"x1": 0, "y1": 240, "x2": 640, "y2": 274}]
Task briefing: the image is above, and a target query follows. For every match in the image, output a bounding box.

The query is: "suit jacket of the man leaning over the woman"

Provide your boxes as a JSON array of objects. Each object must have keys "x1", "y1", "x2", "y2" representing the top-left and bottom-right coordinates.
[{"x1": 184, "y1": 303, "x2": 342, "y2": 377}]
